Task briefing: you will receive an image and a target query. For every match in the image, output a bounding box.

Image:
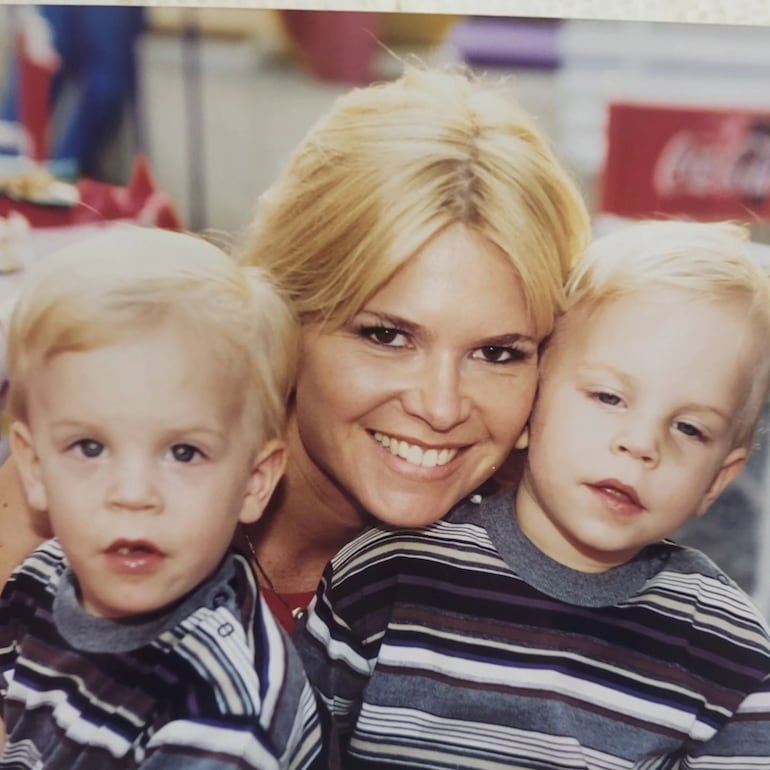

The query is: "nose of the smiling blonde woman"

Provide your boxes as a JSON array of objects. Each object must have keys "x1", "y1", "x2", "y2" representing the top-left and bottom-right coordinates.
[{"x1": 403, "y1": 355, "x2": 471, "y2": 431}]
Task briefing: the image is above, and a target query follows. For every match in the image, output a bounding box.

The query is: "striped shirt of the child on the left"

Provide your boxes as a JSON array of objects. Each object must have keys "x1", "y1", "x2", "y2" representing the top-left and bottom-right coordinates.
[{"x1": 0, "y1": 540, "x2": 320, "y2": 770}]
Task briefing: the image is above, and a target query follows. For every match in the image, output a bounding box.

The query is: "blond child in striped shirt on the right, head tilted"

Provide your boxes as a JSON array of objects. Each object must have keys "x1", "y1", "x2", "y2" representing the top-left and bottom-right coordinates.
[{"x1": 295, "y1": 221, "x2": 770, "y2": 770}]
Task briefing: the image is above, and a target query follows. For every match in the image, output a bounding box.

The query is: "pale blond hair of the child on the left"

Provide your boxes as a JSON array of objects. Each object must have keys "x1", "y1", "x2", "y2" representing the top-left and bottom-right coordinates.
[{"x1": 8, "y1": 227, "x2": 298, "y2": 444}]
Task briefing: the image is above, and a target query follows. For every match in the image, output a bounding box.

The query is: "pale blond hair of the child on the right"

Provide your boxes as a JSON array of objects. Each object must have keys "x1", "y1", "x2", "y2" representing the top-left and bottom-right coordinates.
[{"x1": 545, "y1": 220, "x2": 770, "y2": 447}]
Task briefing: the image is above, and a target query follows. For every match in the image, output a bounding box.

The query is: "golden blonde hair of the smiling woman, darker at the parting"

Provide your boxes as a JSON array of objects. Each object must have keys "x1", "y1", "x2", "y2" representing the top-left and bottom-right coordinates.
[{"x1": 239, "y1": 68, "x2": 589, "y2": 335}]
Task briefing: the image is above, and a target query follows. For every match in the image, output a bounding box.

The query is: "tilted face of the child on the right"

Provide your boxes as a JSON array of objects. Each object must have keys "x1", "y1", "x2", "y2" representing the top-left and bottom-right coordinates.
[{"x1": 517, "y1": 290, "x2": 754, "y2": 572}]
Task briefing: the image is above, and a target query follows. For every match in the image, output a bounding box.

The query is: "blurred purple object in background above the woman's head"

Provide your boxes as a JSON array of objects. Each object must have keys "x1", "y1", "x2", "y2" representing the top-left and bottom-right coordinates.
[{"x1": 448, "y1": 17, "x2": 561, "y2": 70}]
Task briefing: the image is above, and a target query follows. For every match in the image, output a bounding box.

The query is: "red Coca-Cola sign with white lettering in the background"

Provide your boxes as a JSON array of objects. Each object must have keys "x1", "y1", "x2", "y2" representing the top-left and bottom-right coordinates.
[{"x1": 600, "y1": 104, "x2": 770, "y2": 219}]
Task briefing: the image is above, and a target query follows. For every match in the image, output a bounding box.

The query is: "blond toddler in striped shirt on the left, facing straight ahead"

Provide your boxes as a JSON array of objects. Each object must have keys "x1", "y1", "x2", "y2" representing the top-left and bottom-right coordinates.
[{"x1": 0, "y1": 228, "x2": 322, "y2": 770}]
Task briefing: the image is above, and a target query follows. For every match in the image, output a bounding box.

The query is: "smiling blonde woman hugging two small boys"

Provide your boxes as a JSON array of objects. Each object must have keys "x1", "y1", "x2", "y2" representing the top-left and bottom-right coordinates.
[{"x1": 0, "y1": 69, "x2": 589, "y2": 627}]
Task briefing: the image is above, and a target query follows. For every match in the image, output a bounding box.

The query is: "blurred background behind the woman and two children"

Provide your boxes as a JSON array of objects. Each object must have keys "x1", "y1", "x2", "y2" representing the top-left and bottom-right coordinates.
[{"x1": 0, "y1": 6, "x2": 770, "y2": 614}]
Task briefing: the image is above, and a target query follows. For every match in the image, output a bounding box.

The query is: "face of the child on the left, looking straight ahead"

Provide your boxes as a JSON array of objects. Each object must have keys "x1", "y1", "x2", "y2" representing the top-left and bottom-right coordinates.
[{"x1": 13, "y1": 326, "x2": 283, "y2": 617}]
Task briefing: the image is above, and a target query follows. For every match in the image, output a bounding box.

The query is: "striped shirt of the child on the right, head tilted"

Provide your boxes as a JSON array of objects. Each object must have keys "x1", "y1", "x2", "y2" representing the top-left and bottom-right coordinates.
[{"x1": 295, "y1": 492, "x2": 770, "y2": 770}]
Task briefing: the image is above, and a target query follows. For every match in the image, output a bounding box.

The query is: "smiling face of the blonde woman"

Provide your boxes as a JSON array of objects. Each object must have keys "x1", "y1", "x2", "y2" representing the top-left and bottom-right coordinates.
[{"x1": 290, "y1": 219, "x2": 540, "y2": 527}]
